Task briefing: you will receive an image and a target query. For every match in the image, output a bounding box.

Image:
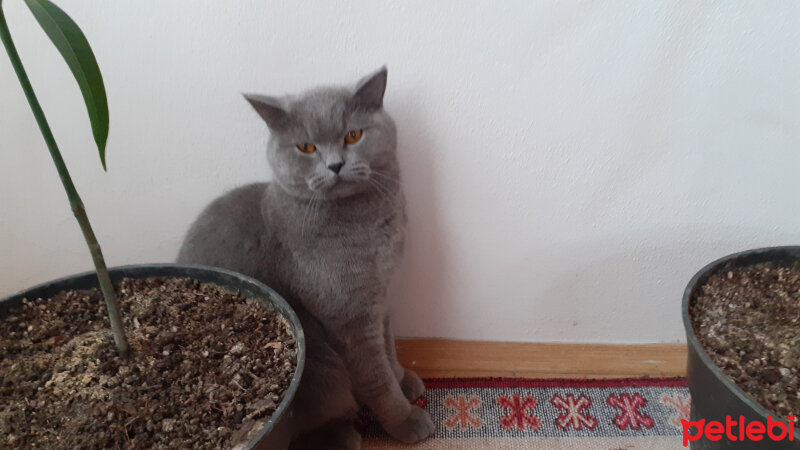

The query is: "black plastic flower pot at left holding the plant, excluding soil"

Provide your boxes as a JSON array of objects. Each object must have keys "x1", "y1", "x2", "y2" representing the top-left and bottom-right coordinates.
[{"x1": 0, "y1": 264, "x2": 306, "y2": 449}]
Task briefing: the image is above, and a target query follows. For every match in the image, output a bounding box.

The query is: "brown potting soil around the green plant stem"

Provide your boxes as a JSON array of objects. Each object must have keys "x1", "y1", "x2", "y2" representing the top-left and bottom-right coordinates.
[{"x1": 0, "y1": 278, "x2": 296, "y2": 449}]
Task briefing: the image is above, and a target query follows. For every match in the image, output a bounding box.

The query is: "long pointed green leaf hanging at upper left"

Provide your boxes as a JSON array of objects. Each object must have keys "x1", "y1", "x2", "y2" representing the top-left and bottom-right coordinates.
[{"x1": 25, "y1": 0, "x2": 108, "y2": 170}]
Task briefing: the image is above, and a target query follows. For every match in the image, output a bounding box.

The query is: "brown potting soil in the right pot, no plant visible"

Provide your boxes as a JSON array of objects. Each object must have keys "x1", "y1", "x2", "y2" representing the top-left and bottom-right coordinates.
[{"x1": 689, "y1": 264, "x2": 800, "y2": 419}]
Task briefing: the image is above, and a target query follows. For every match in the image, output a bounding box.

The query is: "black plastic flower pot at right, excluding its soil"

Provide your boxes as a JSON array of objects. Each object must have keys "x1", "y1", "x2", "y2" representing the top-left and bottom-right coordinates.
[{"x1": 681, "y1": 247, "x2": 800, "y2": 449}]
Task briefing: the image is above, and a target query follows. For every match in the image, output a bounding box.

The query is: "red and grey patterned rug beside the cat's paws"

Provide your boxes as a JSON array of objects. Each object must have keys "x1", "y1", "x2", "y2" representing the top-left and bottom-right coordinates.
[{"x1": 363, "y1": 378, "x2": 689, "y2": 450}]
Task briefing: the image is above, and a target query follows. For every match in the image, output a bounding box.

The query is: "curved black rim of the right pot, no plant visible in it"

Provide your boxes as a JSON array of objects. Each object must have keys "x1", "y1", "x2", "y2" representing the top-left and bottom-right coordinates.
[{"x1": 681, "y1": 246, "x2": 800, "y2": 419}]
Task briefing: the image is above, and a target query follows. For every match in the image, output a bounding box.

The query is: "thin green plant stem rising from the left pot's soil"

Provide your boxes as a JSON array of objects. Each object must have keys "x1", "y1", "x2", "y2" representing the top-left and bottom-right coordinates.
[{"x1": 0, "y1": 0, "x2": 130, "y2": 356}]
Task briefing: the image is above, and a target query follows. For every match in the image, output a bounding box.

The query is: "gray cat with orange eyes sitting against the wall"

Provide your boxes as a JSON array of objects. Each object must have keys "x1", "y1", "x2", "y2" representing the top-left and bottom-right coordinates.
[{"x1": 178, "y1": 67, "x2": 434, "y2": 449}]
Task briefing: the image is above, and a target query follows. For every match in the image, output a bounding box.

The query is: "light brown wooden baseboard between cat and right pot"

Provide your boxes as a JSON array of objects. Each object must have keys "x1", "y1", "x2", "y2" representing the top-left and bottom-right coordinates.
[{"x1": 397, "y1": 339, "x2": 686, "y2": 378}]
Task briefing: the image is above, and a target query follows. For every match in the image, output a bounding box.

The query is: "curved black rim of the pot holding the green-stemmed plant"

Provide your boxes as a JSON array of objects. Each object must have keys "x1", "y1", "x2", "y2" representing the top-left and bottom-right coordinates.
[{"x1": 0, "y1": 263, "x2": 306, "y2": 449}]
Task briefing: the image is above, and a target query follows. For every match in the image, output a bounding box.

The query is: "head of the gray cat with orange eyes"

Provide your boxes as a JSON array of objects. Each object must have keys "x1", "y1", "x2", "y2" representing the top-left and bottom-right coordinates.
[{"x1": 245, "y1": 67, "x2": 398, "y2": 199}]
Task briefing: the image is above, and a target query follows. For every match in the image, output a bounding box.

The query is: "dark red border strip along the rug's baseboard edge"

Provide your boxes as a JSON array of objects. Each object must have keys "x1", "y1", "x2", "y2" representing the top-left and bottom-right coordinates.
[{"x1": 423, "y1": 377, "x2": 687, "y2": 389}]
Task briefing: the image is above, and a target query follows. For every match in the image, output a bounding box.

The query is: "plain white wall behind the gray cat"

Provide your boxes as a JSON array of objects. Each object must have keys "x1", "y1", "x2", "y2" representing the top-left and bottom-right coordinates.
[{"x1": 0, "y1": 0, "x2": 800, "y2": 342}]
